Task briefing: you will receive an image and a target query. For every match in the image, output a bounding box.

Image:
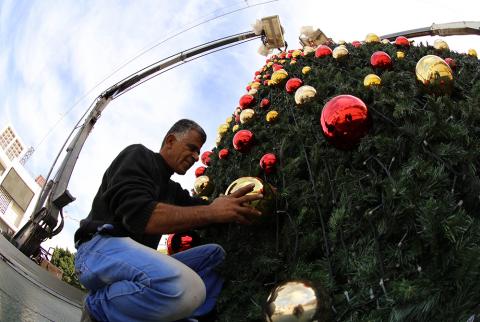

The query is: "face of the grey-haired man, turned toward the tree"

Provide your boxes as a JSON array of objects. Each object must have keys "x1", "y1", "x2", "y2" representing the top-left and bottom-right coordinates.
[{"x1": 170, "y1": 130, "x2": 203, "y2": 174}]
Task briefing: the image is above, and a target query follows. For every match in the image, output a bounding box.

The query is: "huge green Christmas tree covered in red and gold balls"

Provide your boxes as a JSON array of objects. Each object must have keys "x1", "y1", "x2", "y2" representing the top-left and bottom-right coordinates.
[{"x1": 196, "y1": 35, "x2": 480, "y2": 322}]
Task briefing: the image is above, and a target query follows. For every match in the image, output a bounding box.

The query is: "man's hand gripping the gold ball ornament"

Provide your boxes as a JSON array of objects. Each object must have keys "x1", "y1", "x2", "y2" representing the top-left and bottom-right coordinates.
[{"x1": 209, "y1": 184, "x2": 263, "y2": 224}]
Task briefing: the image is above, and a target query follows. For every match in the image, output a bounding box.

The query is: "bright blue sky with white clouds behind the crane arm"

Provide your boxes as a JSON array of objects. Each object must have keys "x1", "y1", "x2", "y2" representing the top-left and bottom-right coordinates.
[{"x1": 0, "y1": 0, "x2": 480, "y2": 251}]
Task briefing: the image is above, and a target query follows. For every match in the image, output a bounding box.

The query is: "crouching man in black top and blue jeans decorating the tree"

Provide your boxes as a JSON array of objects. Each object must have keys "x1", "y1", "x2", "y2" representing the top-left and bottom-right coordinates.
[{"x1": 75, "y1": 119, "x2": 262, "y2": 322}]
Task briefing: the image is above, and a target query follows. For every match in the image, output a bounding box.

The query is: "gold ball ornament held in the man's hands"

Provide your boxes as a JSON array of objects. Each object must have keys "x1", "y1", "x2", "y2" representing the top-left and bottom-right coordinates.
[{"x1": 225, "y1": 177, "x2": 275, "y2": 216}]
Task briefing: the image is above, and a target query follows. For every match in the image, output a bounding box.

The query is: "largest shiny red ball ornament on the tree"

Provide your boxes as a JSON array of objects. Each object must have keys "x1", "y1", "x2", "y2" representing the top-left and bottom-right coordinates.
[{"x1": 320, "y1": 95, "x2": 370, "y2": 149}]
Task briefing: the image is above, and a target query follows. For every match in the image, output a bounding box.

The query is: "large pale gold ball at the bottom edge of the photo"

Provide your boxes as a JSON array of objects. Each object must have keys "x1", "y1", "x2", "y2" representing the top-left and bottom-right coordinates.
[{"x1": 265, "y1": 280, "x2": 325, "y2": 322}]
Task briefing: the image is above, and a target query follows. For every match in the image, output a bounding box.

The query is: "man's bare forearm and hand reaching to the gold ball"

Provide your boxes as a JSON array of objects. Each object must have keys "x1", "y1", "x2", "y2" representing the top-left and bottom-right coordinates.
[{"x1": 145, "y1": 185, "x2": 263, "y2": 235}]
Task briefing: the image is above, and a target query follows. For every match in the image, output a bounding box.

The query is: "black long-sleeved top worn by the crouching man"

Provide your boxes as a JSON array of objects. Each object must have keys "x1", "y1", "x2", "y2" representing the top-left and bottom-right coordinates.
[{"x1": 75, "y1": 144, "x2": 207, "y2": 249}]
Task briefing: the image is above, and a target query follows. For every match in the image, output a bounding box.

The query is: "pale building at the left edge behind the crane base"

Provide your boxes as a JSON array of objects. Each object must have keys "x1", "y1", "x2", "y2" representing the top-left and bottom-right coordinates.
[{"x1": 0, "y1": 125, "x2": 41, "y2": 236}]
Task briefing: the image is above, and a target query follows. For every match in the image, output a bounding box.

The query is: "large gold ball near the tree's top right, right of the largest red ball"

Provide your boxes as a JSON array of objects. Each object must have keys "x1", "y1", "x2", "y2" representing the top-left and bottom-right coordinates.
[{"x1": 415, "y1": 55, "x2": 453, "y2": 95}]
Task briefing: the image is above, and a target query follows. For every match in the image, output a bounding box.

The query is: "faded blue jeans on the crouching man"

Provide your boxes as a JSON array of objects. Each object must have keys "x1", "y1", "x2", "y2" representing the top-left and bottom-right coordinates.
[{"x1": 75, "y1": 234, "x2": 225, "y2": 322}]
